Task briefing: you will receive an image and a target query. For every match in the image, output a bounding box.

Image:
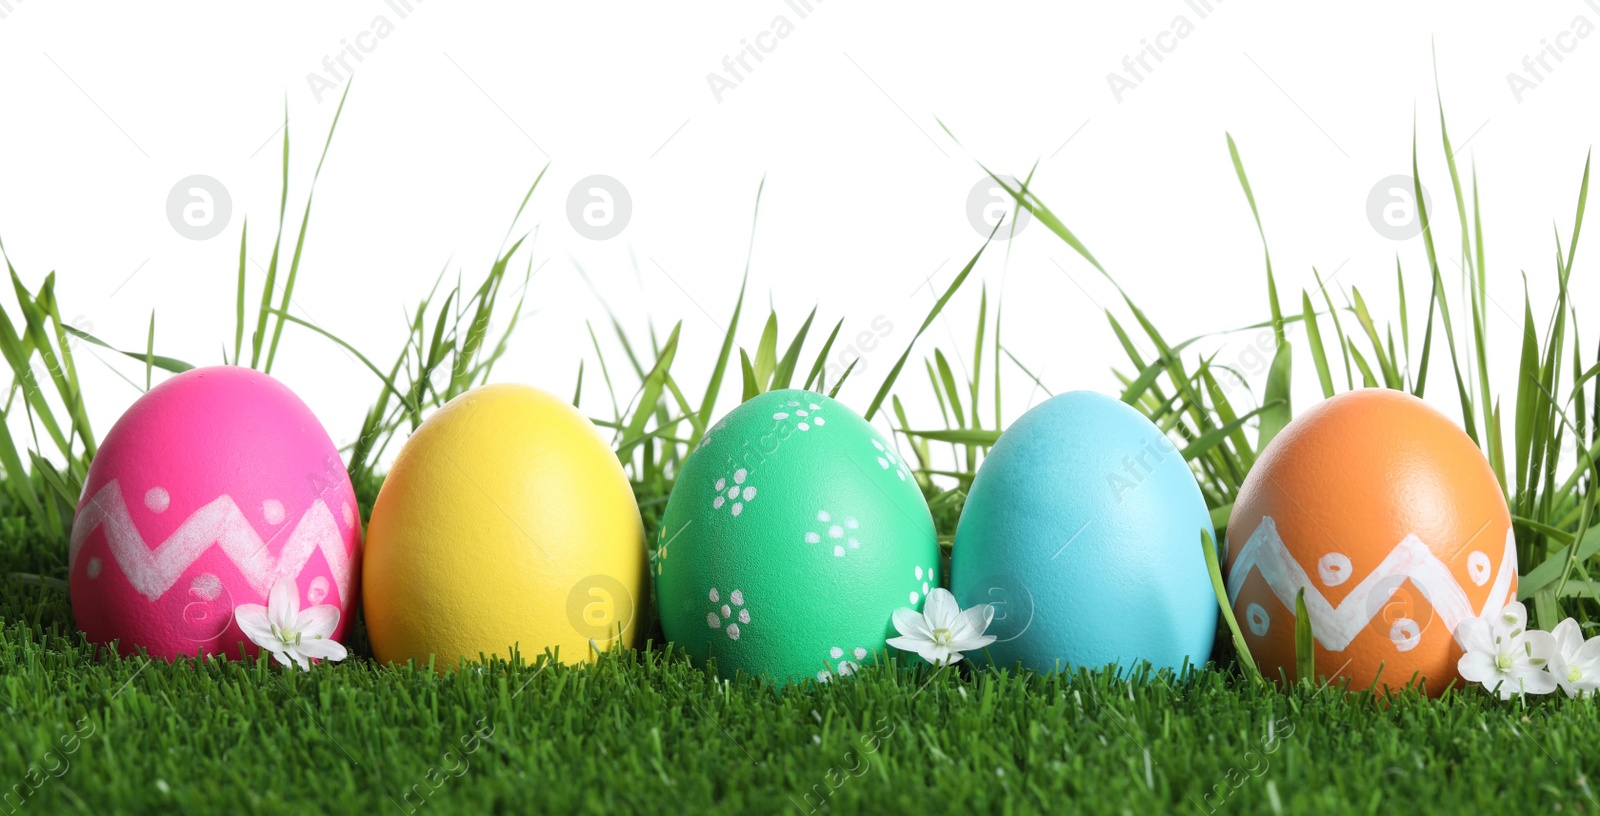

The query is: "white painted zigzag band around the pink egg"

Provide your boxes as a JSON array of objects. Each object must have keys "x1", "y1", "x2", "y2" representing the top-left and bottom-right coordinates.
[{"x1": 67, "y1": 480, "x2": 352, "y2": 600}]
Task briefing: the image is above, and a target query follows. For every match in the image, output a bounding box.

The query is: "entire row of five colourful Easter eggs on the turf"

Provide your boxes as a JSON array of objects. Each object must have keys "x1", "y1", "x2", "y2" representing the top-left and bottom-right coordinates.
[{"x1": 70, "y1": 366, "x2": 1515, "y2": 688}]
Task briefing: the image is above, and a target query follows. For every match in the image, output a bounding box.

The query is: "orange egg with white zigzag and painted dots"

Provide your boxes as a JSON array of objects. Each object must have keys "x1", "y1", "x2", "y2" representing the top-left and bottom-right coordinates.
[{"x1": 1226, "y1": 389, "x2": 1517, "y2": 696}]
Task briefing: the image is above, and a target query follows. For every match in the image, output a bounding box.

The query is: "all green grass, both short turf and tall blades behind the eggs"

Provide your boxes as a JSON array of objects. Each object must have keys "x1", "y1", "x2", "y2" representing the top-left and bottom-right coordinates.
[{"x1": 0, "y1": 78, "x2": 1600, "y2": 814}]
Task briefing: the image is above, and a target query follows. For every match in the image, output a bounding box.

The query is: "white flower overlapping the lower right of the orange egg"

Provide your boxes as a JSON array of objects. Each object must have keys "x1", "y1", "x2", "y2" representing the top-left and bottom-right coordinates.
[{"x1": 1456, "y1": 602, "x2": 1557, "y2": 699}]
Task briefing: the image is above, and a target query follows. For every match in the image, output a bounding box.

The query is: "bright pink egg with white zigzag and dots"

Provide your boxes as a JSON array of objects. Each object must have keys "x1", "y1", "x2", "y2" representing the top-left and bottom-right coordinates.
[{"x1": 69, "y1": 366, "x2": 362, "y2": 659}]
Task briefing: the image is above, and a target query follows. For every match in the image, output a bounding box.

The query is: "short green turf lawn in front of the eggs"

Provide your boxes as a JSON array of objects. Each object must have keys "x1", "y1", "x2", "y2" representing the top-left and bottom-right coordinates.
[{"x1": 9, "y1": 520, "x2": 1600, "y2": 814}]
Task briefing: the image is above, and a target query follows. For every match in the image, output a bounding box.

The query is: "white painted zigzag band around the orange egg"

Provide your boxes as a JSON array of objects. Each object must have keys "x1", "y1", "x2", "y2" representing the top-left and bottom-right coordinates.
[{"x1": 1227, "y1": 515, "x2": 1517, "y2": 651}]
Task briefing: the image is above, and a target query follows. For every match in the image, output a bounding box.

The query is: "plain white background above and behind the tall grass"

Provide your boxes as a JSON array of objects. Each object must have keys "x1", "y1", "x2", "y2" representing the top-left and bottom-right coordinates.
[{"x1": 0, "y1": 0, "x2": 1600, "y2": 460}]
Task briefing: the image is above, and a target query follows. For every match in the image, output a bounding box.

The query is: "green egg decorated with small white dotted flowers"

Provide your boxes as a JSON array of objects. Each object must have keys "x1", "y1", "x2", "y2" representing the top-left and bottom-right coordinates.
[{"x1": 651, "y1": 390, "x2": 939, "y2": 683}]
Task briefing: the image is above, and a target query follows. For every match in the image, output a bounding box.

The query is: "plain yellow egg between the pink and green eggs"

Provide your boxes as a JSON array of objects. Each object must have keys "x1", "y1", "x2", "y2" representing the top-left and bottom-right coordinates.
[{"x1": 362, "y1": 386, "x2": 648, "y2": 669}]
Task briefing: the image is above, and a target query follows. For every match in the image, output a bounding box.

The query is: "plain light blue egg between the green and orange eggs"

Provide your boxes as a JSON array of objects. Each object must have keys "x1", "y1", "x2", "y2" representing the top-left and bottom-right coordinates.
[{"x1": 950, "y1": 390, "x2": 1218, "y2": 672}]
